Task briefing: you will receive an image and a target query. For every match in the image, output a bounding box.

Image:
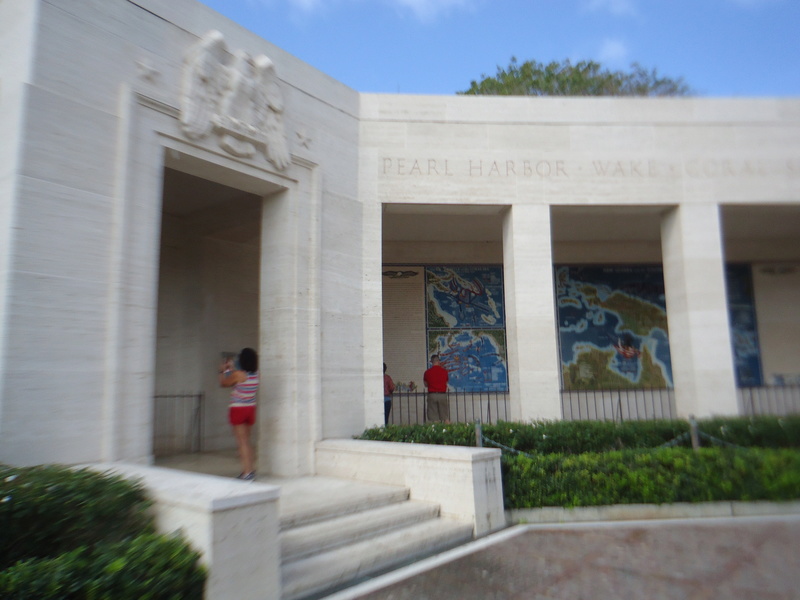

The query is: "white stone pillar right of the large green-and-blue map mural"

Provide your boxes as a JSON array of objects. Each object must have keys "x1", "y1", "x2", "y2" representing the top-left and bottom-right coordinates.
[{"x1": 661, "y1": 204, "x2": 738, "y2": 417}]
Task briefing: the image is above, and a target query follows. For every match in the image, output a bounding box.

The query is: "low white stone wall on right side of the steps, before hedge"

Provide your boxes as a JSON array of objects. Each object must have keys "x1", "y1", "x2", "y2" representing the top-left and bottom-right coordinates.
[{"x1": 316, "y1": 440, "x2": 506, "y2": 537}]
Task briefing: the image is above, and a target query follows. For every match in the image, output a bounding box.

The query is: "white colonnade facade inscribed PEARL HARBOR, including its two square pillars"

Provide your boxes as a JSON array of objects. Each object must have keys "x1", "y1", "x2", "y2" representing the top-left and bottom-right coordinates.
[{"x1": 360, "y1": 95, "x2": 800, "y2": 418}]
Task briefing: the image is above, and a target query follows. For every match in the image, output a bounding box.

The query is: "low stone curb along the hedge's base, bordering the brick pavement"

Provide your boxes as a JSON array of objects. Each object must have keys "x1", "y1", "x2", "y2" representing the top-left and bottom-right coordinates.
[{"x1": 506, "y1": 500, "x2": 800, "y2": 525}]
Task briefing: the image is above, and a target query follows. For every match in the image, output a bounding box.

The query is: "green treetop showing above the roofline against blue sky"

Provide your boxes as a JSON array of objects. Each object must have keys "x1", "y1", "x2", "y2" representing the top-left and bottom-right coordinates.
[{"x1": 458, "y1": 57, "x2": 692, "y2": 96}]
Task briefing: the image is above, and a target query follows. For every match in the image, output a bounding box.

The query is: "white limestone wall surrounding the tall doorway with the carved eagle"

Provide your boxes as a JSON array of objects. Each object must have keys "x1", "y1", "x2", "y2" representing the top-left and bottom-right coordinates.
[{"x1": 0, "y1": 0, "x2": 367, "y2": 473}]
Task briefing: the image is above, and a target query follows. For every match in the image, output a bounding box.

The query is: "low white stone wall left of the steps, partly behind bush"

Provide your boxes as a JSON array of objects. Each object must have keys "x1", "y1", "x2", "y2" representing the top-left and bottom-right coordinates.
[{"x1": 90, "y1": 463, "x2": 281, "y2": 600}]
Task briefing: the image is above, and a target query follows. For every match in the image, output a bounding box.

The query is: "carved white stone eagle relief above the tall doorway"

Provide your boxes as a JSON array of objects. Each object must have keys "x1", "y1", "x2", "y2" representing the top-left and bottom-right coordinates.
[{"x1": 181, "y1": 31, "x2": 290, "y2": 170}]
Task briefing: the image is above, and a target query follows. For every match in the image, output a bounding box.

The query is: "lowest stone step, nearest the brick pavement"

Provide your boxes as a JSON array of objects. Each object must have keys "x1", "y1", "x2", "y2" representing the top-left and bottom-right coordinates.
[{"x1": 281, "y1": 518, "x2": 472, "y2": 600}]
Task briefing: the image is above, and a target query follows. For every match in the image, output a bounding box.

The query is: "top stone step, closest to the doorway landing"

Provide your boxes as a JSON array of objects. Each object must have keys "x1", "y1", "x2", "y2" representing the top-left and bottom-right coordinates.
[{"x1": 280, "y1": 477, "x2": 409, "y2": 531}]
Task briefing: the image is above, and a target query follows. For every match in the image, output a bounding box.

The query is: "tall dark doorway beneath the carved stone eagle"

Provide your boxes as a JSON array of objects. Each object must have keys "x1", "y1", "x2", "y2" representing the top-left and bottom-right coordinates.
[{"x1": 153, "y1": 167, "x2": 263, "y2": 457}]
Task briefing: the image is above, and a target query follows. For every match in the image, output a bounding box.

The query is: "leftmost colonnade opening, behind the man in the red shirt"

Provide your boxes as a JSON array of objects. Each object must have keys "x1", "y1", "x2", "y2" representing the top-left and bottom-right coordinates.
[{"x1": 381, "y1": 204, "x2": 508, "y2": 424}]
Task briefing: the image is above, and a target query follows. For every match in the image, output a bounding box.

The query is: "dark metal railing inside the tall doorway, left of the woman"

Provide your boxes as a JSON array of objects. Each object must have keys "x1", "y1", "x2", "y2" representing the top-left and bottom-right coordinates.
[{"x1": 153, "y1": 392, "x2": 203, "y2": 457}]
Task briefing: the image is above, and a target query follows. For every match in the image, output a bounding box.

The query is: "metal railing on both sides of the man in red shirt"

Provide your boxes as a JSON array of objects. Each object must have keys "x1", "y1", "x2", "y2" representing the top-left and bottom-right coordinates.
[{"x1": 389, "y1": 391, "x2": 509, "y2": 425}]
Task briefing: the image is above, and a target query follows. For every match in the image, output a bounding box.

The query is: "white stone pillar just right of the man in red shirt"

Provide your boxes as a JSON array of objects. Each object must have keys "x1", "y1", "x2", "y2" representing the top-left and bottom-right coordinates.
[{"x1": 503, "y1": 205, "x2": 561, "y2": 421}]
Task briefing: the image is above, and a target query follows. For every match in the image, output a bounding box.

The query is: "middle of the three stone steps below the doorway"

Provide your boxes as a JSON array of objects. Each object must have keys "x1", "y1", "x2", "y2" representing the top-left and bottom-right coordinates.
[{"x1": 281, "y1": 501, "x2": 439, "y2": 563}]
